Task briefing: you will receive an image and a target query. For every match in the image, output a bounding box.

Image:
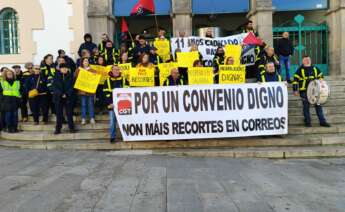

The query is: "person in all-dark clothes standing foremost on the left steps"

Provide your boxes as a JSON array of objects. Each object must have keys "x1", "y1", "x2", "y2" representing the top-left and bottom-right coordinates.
[{"x1": 52, "y1": 64, "x2": 76, "y2": 135}]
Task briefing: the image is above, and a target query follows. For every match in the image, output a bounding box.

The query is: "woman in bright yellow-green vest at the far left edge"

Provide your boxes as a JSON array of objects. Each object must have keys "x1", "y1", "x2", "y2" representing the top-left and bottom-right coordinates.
[{"x1": 0, "y1": 69, "x2": 21, "y2": 133}]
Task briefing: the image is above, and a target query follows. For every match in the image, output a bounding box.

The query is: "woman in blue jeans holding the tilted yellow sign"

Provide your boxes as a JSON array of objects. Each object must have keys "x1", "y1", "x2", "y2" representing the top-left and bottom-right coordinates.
[{"x1": 74, "y1": 57, "x2": 96, "y2": 125}]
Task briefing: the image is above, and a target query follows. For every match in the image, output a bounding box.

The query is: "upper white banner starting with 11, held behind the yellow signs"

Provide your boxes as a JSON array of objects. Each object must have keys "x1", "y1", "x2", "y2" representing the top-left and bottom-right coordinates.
[{"x1": 170, "y1": 33, "x2": 255, "y2": 66}]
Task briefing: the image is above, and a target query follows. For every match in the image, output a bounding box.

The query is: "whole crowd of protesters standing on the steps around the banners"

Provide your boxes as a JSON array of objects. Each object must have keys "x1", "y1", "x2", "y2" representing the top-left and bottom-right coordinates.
[{"x1": 0, "y1": 22, "x2": 329, "y2": 142}]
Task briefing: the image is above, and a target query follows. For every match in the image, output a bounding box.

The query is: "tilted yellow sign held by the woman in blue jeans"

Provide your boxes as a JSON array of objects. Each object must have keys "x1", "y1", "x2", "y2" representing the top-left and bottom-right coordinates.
[{"x1": 74, "y1": 68, "x2": 102, "y2": 93}]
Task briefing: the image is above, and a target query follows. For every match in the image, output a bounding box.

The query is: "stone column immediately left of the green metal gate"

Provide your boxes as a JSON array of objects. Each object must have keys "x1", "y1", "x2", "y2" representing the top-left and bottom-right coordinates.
[{"x1": 247, "y1": 0, "x2": 273, "y2": 46}]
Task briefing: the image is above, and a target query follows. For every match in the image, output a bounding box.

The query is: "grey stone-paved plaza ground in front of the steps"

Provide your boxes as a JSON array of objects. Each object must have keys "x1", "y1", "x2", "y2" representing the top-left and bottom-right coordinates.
[{"x1": 0, "y1": 149, "x2": 345, "y2": 212}]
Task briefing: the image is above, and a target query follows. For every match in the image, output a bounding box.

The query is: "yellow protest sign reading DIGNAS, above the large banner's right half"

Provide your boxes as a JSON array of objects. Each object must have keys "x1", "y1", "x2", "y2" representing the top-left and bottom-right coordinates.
[{"x1": 219, "y1": 65, "x2": 246, "y2": 84}]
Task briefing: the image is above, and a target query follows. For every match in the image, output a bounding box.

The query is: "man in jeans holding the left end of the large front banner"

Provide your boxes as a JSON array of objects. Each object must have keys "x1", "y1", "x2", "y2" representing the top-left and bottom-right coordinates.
[{"x1": 103, "y1": 65, "x2": 128, "y2": 143}]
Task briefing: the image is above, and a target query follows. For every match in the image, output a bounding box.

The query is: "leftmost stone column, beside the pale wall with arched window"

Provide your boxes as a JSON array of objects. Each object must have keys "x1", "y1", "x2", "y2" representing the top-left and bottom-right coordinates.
[{"x1": 88, "y1": 0, "x2": 115, "y2": 43}]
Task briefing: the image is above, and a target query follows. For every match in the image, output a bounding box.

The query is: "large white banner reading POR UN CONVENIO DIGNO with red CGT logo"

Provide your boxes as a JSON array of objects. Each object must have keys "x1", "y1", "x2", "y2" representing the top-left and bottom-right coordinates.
[{"x1": 113, "y1": 83, "x2": 288, "y2": 141}]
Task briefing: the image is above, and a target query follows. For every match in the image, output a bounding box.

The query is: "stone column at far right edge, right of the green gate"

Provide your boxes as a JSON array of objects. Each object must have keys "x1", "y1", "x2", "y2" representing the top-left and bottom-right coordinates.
[{"x1": 327, "y1": 0, "x2": 345, "y2": 76}]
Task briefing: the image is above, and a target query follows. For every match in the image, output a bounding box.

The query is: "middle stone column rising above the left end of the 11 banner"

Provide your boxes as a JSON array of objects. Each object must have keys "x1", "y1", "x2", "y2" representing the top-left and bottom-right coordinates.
[{"x1": 171, "y1": 0, "x2": 193, "y2": 36}]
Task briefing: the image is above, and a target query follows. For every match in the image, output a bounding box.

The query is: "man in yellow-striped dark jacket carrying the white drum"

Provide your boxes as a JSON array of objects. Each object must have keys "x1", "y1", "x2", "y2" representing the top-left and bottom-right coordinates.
[{"x1": 292, "y1": 55, "x2": 331, "y2": 127}]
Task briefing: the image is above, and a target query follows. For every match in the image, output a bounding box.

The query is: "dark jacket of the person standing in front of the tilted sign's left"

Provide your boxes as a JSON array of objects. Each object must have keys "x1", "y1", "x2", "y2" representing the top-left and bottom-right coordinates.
[{"x1": 52, "y1": 71, "x2": 74, "y2": 101}]
